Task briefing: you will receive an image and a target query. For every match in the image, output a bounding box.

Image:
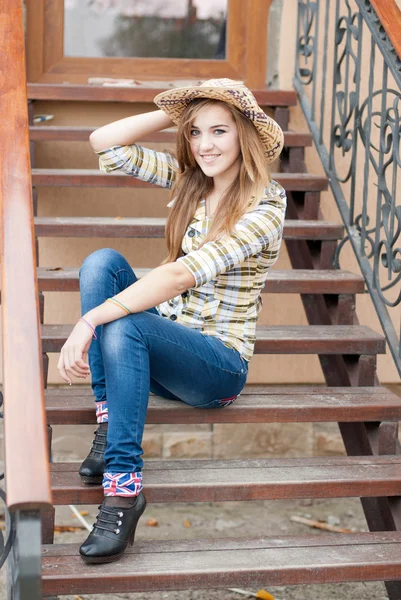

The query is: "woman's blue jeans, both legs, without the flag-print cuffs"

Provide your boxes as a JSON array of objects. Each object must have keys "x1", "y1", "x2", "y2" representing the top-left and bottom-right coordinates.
[{"x1": 80, "y1": 248, "x2": 248, "y2": 473}]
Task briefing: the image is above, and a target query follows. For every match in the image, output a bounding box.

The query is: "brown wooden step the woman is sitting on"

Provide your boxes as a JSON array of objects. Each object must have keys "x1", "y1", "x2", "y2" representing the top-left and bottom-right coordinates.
[{"x1": 45, "y1": 385, "x2": 401, "y2": 425}]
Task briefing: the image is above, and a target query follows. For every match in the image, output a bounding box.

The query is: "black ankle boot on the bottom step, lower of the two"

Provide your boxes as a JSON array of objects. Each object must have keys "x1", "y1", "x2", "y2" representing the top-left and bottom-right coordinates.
[{"x1": 79, "y1": 492, "x2": 146, "y2": 564}]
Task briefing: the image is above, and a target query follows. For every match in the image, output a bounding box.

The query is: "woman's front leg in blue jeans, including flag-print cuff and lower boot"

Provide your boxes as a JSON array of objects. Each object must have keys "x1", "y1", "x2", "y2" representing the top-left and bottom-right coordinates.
[{"x1": 80, "y1": 252, "x2": 247, "y2": 563}]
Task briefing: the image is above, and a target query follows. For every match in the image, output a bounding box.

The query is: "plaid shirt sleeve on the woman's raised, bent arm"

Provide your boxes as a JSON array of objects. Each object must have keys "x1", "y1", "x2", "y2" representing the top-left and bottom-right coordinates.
[{"x1": 97, "y1": 144, "x2": 178, "y2": 188}]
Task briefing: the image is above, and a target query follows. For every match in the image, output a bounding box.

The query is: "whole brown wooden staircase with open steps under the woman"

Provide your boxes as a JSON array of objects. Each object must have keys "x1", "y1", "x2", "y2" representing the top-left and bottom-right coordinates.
[{"x1": 28, "y1": 84, "x2": 401, "y2": 600}]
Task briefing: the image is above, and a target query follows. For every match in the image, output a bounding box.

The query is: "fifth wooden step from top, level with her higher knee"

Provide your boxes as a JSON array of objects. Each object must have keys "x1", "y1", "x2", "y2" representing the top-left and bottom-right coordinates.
[{"x1": 38, "y1": 267, "x2": 365, "y2": 294}]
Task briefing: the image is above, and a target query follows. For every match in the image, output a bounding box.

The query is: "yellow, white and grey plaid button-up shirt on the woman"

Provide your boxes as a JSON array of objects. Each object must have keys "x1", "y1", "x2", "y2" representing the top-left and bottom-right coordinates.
[{"x1": 98, "y1": 144, "x2": 286, "y2": 360}]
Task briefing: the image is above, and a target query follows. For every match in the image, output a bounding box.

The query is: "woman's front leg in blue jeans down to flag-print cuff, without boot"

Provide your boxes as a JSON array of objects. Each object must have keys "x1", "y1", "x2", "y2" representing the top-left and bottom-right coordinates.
[{"x1": 101, "y1": 312, "x2": 247, "y2": 486}]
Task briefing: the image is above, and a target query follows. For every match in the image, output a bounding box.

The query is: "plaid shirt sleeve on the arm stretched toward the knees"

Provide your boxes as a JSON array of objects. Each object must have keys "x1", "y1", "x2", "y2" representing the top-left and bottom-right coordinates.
[{"x1": 177, "y1": 201, "x2": 285, "y2": 288}]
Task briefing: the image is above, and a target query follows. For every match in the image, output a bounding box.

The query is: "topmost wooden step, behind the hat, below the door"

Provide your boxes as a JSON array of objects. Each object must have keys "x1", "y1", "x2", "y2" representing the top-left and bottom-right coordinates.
[{"x1": 27, "y1": 82, "x2": 297, "y2": 107}]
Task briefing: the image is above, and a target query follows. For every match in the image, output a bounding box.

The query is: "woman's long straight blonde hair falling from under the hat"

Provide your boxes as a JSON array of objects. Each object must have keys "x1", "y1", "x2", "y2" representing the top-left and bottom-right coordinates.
[{"x1": 163, "y1": 98, "x2": 270, "y2": 264}]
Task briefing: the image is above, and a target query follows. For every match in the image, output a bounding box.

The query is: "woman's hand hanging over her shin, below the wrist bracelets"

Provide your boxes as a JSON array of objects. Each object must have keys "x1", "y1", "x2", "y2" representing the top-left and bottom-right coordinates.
[{"x1": 57, "y1": 321, "x2": 93, "y2": 385}]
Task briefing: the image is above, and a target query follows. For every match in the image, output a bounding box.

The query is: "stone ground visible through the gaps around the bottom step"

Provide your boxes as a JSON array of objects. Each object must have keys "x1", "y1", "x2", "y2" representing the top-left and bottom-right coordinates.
[{"x1": 0, "y1": 498, "x2": 387, "y2": 600}]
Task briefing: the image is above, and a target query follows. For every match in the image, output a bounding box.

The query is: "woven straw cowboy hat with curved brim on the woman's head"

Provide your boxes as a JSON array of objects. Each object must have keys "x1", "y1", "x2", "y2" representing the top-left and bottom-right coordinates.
[{"x1": 154, "y1": 79, "x2": 284, "y2": 163}]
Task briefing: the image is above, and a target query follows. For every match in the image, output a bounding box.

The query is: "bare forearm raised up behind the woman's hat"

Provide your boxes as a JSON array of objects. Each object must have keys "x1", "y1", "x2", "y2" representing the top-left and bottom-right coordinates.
[{"x1": 89, "y1": 110, "x2": 174, "y2": 152}]
